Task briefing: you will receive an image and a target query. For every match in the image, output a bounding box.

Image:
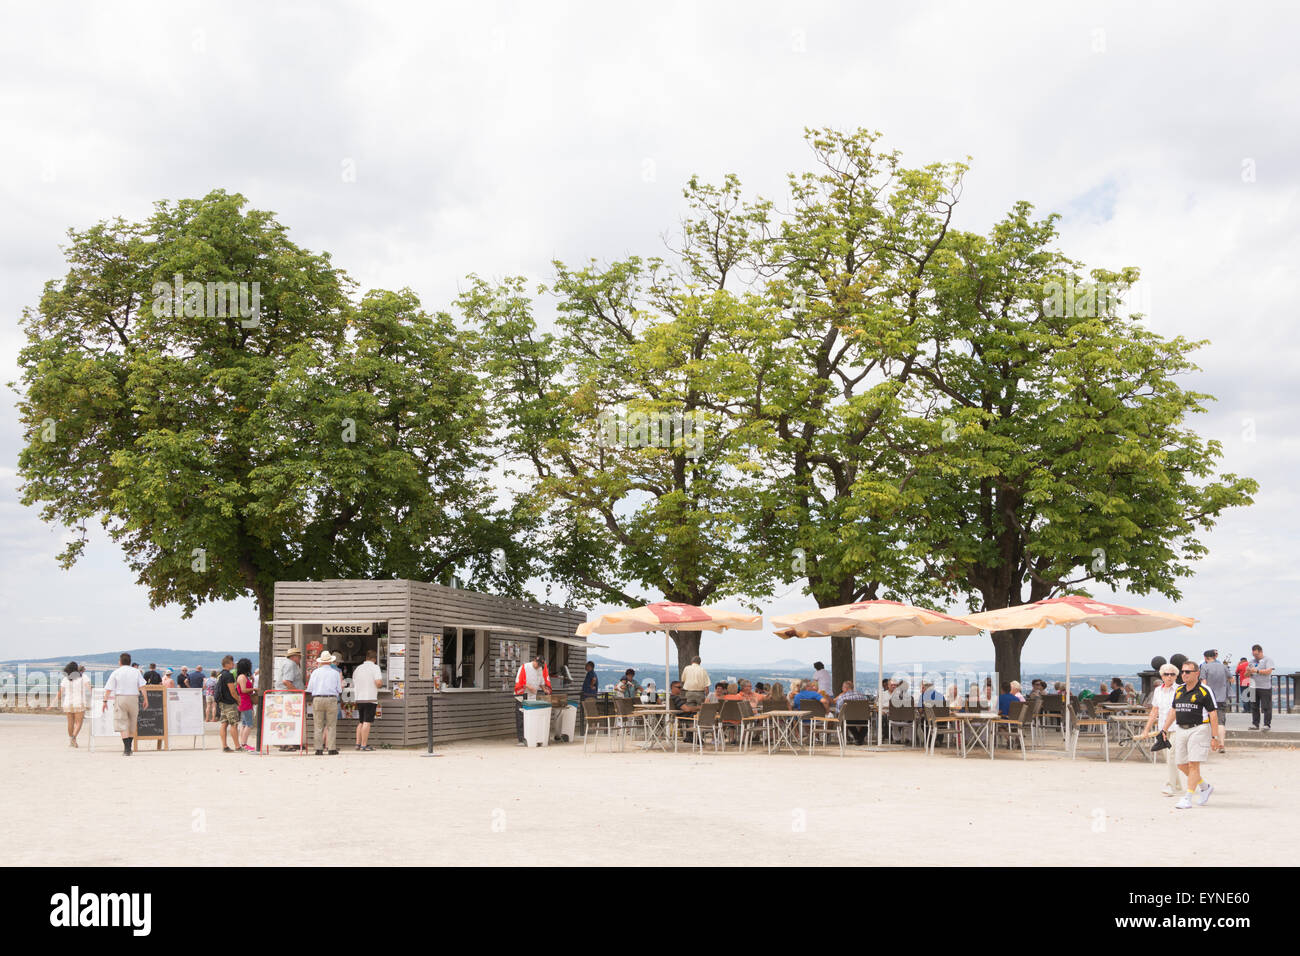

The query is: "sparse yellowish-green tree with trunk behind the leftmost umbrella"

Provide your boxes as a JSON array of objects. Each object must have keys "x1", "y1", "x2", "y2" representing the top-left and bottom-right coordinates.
[{"x1": 460, "y1": 258, "x2": 770, "y2": 665}]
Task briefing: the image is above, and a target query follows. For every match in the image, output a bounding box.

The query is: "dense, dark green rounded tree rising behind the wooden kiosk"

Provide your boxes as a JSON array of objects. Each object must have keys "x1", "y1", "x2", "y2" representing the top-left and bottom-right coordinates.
[{"x1": 18, "y1": 191, "x2": 527, "y2": 687}]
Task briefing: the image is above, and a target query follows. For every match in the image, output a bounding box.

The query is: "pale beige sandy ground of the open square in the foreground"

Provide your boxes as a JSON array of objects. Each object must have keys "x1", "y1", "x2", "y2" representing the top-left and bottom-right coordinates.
[{"x1": 0, "y1": 715, "x2": 1300, "y2": 866}]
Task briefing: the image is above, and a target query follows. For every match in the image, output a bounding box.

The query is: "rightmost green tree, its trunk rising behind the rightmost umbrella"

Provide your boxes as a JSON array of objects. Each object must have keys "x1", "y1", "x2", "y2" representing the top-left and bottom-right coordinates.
[{"x1": 910, "y1": 203, "x2": 1257, "y2": 679}]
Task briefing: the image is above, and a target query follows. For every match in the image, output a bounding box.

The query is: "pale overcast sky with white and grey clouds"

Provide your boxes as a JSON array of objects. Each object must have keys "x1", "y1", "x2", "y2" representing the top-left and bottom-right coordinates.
[{"x1": 0, "y1": 1, "x2": 1300, "y2": 665}]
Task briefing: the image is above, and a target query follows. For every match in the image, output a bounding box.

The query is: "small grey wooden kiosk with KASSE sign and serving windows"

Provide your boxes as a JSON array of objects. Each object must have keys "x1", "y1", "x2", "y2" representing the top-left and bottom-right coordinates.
[{"x1": 270, "y1": 580, "x2": 599, "y2": 747}]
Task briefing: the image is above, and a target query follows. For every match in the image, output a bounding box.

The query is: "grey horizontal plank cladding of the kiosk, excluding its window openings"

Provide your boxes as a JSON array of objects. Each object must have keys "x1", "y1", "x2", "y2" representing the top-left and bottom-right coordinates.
[{"x1": 274, "y1": 580, "x2": 586, "y2": 749}]
